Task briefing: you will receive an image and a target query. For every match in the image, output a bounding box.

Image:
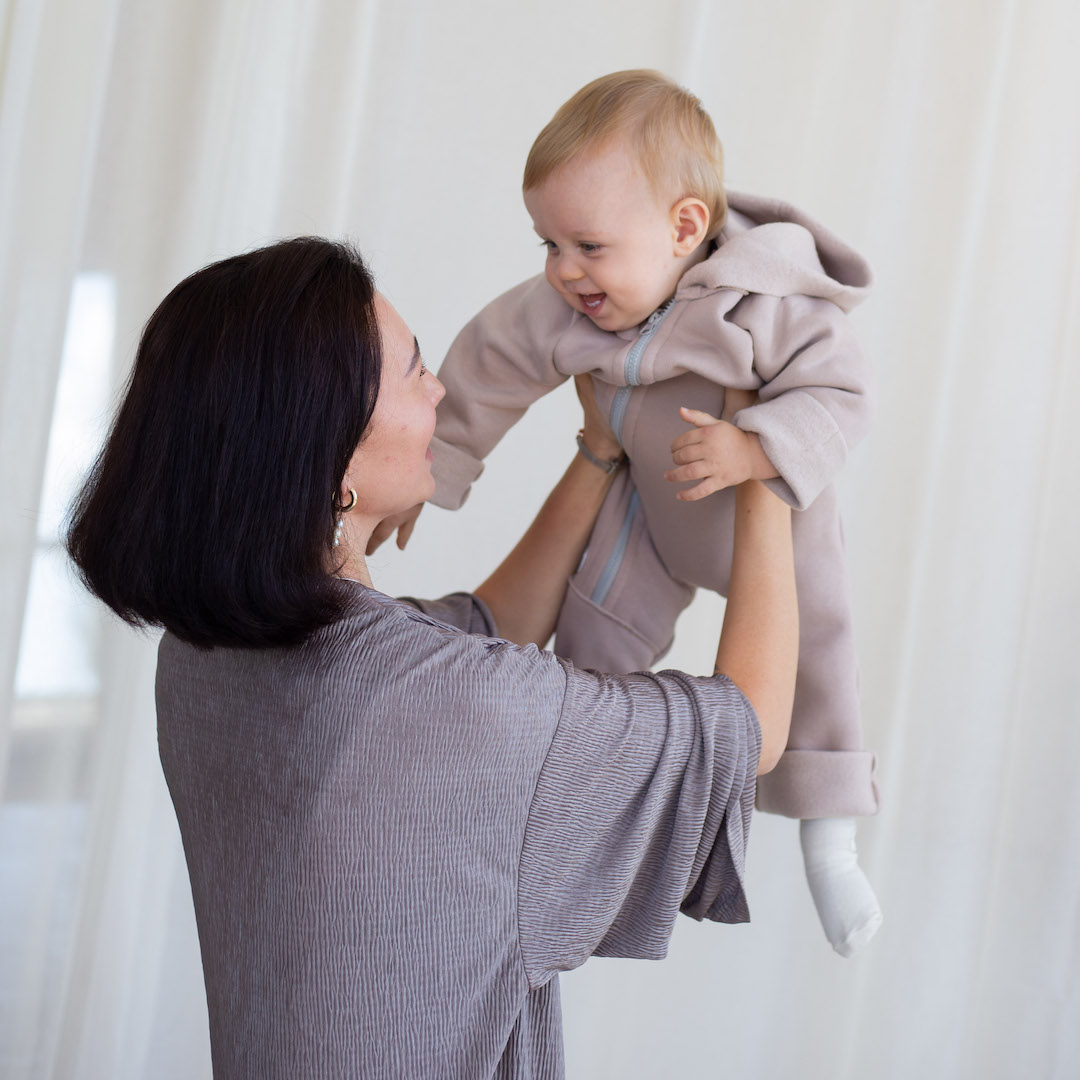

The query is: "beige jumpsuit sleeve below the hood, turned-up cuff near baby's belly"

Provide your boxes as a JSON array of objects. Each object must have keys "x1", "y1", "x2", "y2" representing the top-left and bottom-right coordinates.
[{"x1": 729, "y1": 295, "x2": 873, "y2": 510}]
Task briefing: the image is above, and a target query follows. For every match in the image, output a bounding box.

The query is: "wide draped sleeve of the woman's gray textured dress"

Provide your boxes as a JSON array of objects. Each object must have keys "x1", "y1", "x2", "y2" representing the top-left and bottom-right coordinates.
[{"x1": 518, "y1": 661, "x2": 760, "y2": 987}]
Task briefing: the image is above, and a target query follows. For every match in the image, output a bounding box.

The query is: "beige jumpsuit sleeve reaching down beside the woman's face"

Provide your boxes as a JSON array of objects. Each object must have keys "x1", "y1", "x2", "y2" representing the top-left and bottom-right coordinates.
[{"x1": 431, "y1": 274, "x2": 576, "y2": 510}]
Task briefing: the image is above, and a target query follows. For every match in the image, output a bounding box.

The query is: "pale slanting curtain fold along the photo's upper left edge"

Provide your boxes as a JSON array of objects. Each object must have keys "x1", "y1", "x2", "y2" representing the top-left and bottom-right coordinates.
[{"x1": 0, "y1": 0, "x2": 116, "y2": 781}]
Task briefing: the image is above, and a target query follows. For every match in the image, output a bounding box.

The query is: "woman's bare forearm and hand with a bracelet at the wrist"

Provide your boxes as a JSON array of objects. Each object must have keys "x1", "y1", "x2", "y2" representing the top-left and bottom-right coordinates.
[{"x1": 476, "y1": 376, "x2": 622, "y2": 648}]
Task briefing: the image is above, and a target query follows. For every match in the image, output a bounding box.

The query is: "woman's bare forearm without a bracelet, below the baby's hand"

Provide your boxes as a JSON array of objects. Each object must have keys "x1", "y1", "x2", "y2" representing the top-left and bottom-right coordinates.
[{"x1": 716, "y1": 481, "x2": 799, "y2": 773}]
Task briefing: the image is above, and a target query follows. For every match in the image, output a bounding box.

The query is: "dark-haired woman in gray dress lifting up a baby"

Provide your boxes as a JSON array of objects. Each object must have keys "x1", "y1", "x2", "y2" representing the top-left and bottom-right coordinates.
[{"x1": 68, "y1": 239, "x2": 796, "y2": 1080}]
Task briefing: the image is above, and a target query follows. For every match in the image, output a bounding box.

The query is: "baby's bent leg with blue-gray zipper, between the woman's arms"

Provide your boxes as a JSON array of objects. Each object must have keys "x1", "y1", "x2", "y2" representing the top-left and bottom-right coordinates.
[{"x1": 554, "y1": 470, "x2": 693, "y2": 674}]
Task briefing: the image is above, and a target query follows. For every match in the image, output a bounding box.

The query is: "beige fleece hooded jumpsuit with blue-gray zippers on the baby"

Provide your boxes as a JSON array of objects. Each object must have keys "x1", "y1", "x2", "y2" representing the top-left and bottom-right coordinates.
[{"x1": 432, "y1": 192, "x2": 878, "y2": 819}]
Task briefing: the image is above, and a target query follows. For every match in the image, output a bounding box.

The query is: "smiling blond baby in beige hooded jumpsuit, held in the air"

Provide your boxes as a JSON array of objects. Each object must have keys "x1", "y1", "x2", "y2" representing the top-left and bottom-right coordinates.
[{"x1": 416, "y1": 71, "x2": 881, "y2": 956}]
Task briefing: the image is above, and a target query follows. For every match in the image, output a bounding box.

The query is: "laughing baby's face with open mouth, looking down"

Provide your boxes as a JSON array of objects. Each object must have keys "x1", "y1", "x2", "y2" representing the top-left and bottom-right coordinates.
[{"x1": 525, "y1": 144, "x2": 686, "y2": 330}]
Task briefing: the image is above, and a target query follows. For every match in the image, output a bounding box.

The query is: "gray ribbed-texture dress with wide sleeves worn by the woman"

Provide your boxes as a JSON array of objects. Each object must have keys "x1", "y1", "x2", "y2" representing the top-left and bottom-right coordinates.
[{"x1": 158, "y1": 585, "x2": 760, "y2": 1080}]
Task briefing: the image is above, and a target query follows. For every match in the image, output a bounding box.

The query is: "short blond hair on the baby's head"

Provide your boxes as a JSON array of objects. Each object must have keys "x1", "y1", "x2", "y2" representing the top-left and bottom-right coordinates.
[{"x1": 522, "y1": 68, "x2": 728, "y2": 240}]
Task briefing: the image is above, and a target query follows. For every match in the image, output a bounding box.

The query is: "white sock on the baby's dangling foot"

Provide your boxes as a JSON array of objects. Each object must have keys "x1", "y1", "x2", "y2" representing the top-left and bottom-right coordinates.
[{"x1": 799, "y1": 818, "x2": 881, "y2": 957}]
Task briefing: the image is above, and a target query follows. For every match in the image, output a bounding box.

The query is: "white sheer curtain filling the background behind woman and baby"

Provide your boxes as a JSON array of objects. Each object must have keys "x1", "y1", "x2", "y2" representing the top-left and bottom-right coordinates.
[{"x1": 0, "y1": 0, "x2": 1080, "y2": 1080}]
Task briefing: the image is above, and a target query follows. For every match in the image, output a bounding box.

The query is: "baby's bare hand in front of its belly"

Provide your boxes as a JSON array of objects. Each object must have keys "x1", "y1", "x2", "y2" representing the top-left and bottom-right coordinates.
[{"x1": 664, "y1": 389, "x2": 780, "y2": 502}]
